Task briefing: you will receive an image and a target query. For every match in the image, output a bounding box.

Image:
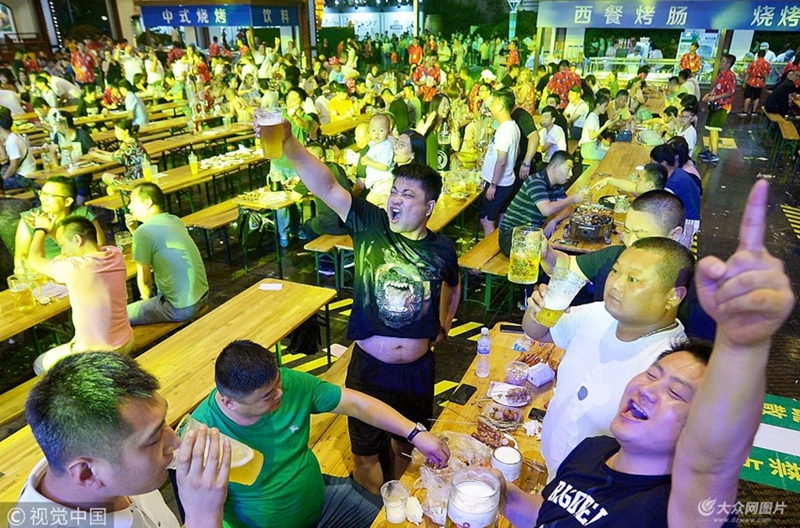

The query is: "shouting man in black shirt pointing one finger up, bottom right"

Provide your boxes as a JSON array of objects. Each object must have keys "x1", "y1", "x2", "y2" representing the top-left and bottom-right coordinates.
[{"x1": 498, "y1": 181, "x2": 795, "y2": 528}]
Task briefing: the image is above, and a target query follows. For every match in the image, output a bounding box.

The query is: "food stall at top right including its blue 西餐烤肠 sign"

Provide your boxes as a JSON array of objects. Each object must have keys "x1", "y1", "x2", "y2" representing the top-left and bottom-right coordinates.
[{"x1": 537, "y1": 0, "x2": 800, "y2": 84}]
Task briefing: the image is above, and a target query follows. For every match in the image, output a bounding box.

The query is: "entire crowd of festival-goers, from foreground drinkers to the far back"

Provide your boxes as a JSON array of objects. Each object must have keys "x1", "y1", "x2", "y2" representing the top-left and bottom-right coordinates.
[{"x1": 0, "y1": 23, "x2": 800, "y2": 528}]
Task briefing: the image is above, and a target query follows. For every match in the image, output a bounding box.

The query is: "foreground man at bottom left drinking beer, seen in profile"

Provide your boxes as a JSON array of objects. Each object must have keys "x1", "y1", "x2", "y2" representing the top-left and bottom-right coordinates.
[{"x1": 17, "y1": 352, "x2": 230, "y2": 528}]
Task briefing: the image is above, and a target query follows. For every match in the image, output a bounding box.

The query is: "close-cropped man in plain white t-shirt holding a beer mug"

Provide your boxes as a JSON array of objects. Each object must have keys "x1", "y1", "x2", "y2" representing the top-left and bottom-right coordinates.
[{"x1": 522, "y1": 237, "x2": 695, "y2": 475}]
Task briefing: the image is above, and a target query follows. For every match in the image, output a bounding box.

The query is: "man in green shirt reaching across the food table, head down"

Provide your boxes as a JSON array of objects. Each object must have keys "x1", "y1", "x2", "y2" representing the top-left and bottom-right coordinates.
[{"x1": 192, "y1": 341, "x2": 450, "y2": 528}]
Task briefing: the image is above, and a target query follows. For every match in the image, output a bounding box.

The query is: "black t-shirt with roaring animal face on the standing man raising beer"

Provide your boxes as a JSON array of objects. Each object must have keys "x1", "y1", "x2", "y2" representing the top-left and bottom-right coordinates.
[{"x1": 346, "y1": 197, "x2": 458, "y2": 340}]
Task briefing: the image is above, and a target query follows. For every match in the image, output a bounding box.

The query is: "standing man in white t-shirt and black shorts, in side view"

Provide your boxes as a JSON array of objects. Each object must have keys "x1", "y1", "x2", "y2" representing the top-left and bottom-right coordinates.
[{"x1": 478, "y1": 88, "x2": 520, "y2": 236}]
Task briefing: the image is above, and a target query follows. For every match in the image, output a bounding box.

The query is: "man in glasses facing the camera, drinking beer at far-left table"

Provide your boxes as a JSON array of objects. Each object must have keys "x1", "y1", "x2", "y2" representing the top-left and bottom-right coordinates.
[{"x1": 14, "y1": 176, "x2": 106, "y2": 273}]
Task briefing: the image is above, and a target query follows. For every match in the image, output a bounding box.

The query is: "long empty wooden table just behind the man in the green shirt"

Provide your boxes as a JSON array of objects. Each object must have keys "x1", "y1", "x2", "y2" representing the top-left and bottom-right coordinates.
[{"x1": 0, "y1": 279, "x2": 336, "y2": 519}]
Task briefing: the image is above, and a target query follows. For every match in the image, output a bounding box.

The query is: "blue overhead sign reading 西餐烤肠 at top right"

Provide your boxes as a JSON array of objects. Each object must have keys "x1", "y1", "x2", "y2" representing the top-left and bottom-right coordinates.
[{"x1": 537, "y1": 0, "x2": 800, "y2": 31}]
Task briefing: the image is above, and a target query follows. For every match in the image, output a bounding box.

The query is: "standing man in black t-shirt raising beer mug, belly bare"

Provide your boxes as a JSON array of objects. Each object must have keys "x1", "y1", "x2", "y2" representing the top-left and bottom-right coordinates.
[{"x1": 283, "y1": 121, "x2": 459, "y2": 494}]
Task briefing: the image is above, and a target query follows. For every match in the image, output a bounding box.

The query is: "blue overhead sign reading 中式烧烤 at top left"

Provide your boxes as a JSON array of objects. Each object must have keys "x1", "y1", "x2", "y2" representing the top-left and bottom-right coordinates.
[{"x1": 142, "y1": 5, "x2": 300, "y2": 27}]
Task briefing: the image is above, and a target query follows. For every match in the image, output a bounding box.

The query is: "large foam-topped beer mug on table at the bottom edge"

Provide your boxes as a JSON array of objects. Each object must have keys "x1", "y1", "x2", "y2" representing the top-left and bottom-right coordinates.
[{"x1": 445, "y1": 467, "x2": 500, "y2": 528}]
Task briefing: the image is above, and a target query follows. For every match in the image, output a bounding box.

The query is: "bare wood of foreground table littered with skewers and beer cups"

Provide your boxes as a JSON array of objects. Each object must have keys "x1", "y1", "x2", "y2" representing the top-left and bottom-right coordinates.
[{"x1": 372, "y1": 323, "x2": 563, "y2": 528}]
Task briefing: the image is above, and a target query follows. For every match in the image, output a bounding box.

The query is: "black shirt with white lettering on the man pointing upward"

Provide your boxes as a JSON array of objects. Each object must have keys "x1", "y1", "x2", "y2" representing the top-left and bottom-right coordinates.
[{"x1": 536, "y1": 436, "x2": 734, "y2": 528}]
